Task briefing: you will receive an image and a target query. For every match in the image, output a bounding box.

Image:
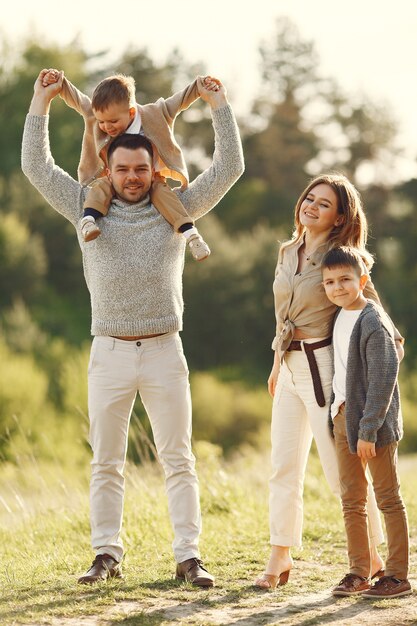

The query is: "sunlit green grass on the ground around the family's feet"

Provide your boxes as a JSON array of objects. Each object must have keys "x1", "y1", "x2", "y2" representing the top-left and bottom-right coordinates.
[{"x1": 0, "y1": 443, "x2": 417, "y2": 626}]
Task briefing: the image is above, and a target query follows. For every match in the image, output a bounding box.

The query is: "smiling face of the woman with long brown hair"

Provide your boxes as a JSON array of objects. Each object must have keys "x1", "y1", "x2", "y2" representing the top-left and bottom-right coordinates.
[{"x1": 299, "y1": 183, "x2": 343, "y2": 233}]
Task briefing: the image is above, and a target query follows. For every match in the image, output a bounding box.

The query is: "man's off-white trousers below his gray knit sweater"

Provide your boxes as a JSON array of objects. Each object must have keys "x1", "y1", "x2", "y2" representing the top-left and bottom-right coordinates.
[{"x1": 88, "y1": 333, "x2": 201, "y2": 563}]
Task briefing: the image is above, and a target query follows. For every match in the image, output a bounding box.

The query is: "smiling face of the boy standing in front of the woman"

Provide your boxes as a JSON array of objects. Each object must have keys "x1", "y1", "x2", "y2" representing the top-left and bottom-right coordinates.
[{"x1": 323, "y1": 265, "x2": 368, "y2": 311}]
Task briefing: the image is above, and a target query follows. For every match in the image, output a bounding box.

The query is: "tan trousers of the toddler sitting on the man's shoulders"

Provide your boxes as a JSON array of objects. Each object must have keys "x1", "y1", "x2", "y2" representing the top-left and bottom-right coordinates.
[{"x1": 84, "y1": 175, "x2": 194, "y2": 232}]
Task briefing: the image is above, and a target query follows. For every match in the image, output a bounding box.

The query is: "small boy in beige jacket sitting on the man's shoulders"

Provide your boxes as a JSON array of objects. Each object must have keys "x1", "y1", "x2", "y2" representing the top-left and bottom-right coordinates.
[{"x1": 42, "y1": 69, "x2": 220, "y2": 261}]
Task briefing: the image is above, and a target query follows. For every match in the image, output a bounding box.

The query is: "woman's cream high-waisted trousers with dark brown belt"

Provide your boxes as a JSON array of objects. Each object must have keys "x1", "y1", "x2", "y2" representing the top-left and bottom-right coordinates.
[{"x1": 269, "y1": 339, "x2": 384, "y2": 547}]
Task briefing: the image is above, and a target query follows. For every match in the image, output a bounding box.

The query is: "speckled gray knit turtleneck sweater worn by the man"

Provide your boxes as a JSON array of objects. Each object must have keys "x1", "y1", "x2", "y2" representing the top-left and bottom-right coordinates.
[{"x1": 22, "y1": 105, "x2": 244, "y2": 336}]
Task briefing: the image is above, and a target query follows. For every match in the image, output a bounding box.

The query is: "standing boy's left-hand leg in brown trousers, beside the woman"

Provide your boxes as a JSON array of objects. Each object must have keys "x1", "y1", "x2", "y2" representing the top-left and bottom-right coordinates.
[{"x1": 334, "y1": 409, "x2": 371, "y2": 579}]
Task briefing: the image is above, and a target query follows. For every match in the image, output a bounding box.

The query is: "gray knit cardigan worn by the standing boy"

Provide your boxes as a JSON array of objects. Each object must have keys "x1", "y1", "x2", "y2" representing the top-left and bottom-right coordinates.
[{"x1": 329, "y1": 301, "x2": 403, "y2": 454}]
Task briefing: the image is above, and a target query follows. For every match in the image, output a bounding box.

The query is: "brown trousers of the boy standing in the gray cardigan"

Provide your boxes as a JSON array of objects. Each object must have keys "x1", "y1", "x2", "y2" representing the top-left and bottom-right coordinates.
[{"x1": 333, "y1": 406, "x2": 409, "y2": 580}]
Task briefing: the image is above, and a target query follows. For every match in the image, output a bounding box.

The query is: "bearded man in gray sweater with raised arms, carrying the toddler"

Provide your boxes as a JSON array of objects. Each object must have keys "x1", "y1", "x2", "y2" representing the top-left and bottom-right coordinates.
[{"x1": 22, "y1": 72, "x2": 244, "y2": 587}]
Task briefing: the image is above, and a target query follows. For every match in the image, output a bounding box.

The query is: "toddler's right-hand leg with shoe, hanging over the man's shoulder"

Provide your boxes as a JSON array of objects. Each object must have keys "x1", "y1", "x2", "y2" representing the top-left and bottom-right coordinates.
[{"x1": 150, "y1": 175, "x2": 210, "y2": 261}]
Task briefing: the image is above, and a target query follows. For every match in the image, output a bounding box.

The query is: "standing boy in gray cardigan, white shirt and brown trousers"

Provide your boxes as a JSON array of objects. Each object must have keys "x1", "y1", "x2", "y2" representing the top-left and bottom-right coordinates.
[{"x1": 322, "y1": 247, "x2": 412, "y2": 599}]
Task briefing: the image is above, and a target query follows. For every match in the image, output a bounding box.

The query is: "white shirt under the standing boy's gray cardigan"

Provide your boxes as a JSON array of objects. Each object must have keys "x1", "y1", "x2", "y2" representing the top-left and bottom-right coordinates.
[{"x1": 330, "y1": 309, "x2": 362, "y2": 419}]
